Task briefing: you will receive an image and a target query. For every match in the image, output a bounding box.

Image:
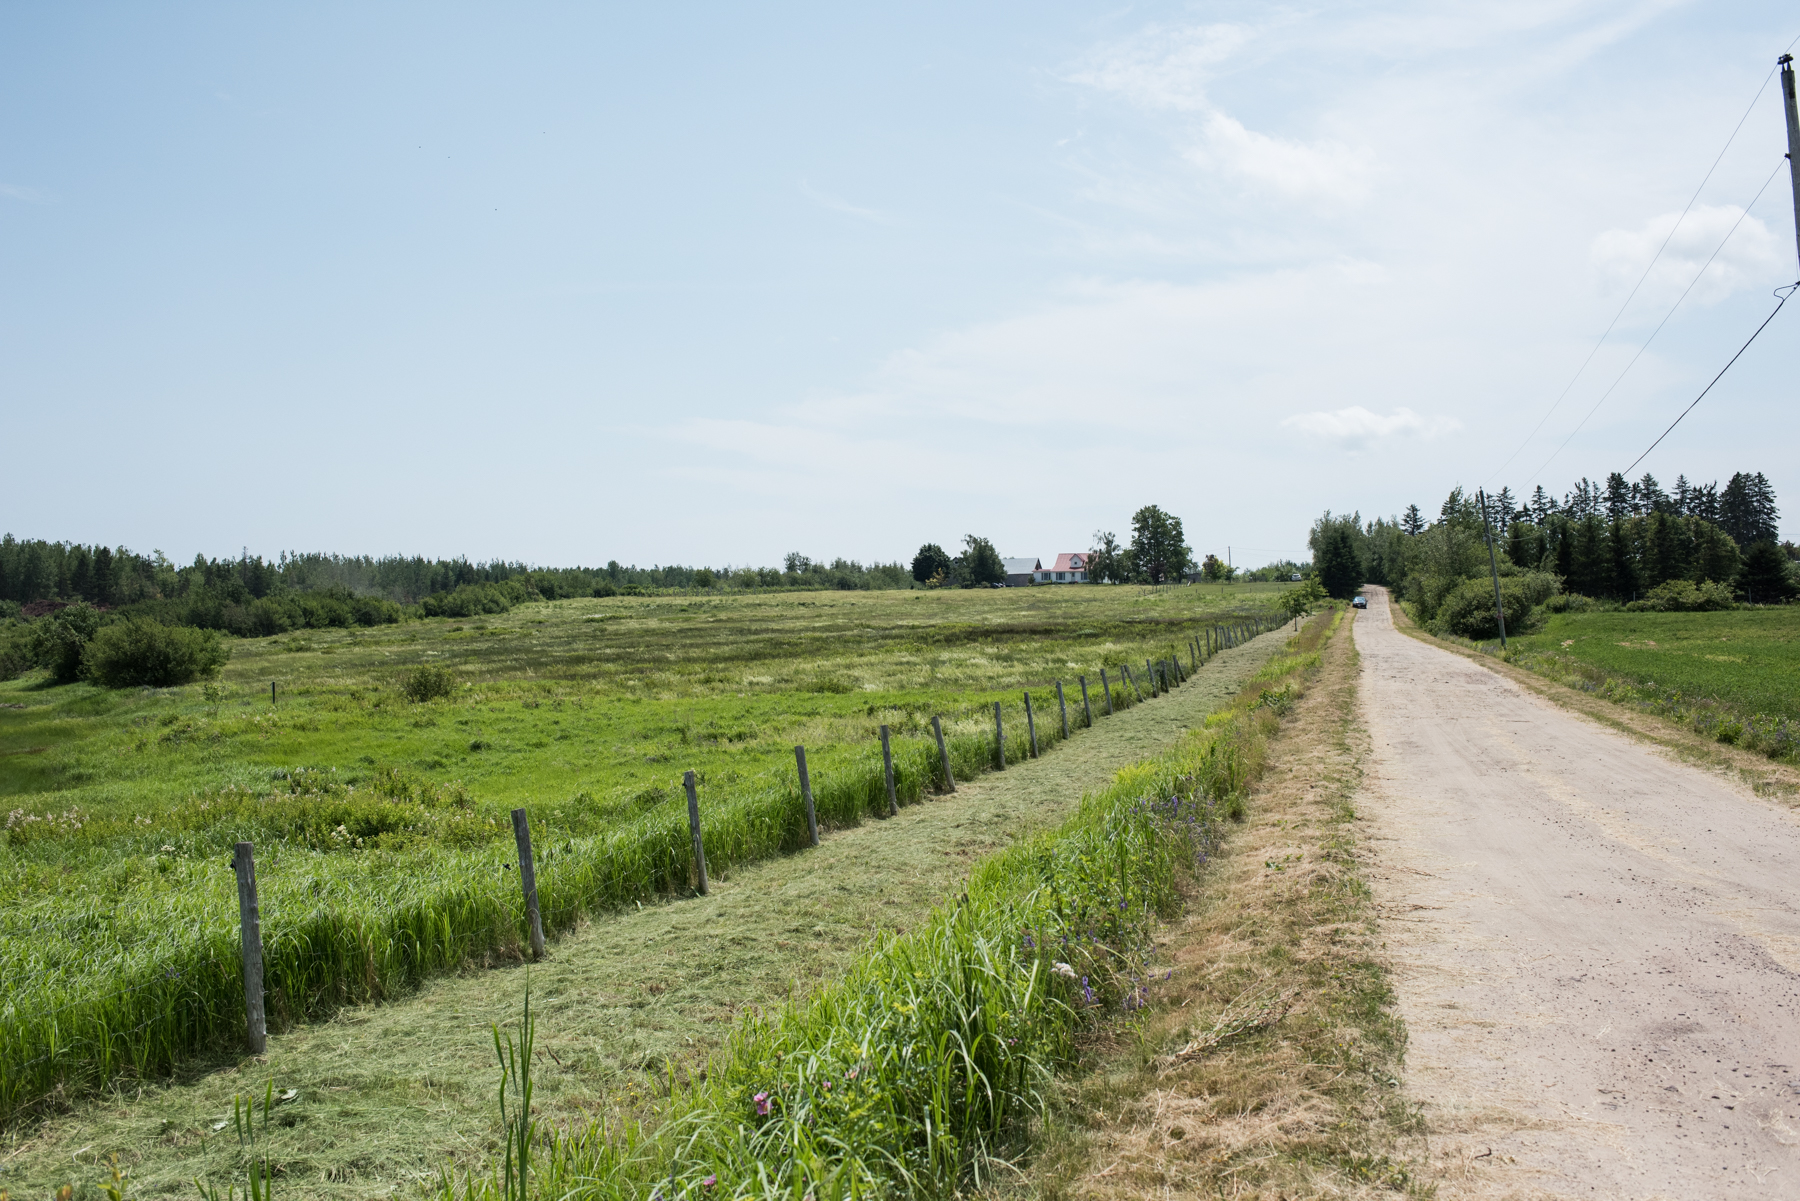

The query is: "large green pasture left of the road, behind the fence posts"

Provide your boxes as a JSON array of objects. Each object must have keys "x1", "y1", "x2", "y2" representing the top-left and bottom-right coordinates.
[{"x1": 0, "y1": 587, "x2": 1274, "y2": 1130}]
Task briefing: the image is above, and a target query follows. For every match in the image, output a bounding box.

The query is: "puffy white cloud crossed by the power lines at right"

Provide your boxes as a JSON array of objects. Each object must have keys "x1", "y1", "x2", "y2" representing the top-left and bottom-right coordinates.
[{"x1": 1589, "y1": 205, "x2": 1786, "y2": 309}]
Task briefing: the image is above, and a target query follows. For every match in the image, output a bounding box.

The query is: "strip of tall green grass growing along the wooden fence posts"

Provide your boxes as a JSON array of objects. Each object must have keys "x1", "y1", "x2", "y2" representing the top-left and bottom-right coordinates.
[{"x1": 0, "y1": 614, "x2": 1285, "y2": 1122}]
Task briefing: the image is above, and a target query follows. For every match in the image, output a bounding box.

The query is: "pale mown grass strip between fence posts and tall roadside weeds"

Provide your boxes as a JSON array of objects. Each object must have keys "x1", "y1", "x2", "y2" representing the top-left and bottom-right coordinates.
[{"x1": 0, "y1": 615, "x2": 1310, "y2": 1201}]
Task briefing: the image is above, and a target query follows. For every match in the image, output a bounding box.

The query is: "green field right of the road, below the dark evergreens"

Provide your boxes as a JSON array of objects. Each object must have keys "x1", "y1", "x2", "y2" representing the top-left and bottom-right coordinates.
[{"x1": 1512, "y1": 605, "x2": 1800, "y2": 758}]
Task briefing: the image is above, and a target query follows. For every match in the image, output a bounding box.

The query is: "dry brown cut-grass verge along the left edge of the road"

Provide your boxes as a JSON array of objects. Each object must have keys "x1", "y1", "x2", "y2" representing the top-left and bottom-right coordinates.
[{"x1": 1021, "y1": 623, "x2": 1422, "y2": 1201}]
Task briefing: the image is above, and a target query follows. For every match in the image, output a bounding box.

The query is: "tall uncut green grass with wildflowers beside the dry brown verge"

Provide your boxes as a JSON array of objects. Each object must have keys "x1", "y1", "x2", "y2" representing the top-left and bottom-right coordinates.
[{"x1": 414, "y1": 615, "x2": 1339, "y2": 1201}]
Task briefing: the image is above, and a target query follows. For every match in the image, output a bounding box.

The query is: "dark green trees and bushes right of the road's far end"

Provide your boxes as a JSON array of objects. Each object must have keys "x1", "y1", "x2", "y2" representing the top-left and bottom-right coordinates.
[{"x1": 1310, "y1": 472, "x2": 1800, "y2": 637}]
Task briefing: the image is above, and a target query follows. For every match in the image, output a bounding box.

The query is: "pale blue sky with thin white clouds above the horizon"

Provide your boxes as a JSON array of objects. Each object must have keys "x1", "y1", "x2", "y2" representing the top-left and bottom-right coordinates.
[{"x1": 0, "y1": 0, "x2": 1800, "y2": 565}]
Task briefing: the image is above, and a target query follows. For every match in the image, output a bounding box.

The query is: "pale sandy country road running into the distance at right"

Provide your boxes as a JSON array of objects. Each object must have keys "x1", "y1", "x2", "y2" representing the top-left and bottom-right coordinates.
[{"x1": 1355, "y1": 589, "x2": 1800, "y2": 1197}]
